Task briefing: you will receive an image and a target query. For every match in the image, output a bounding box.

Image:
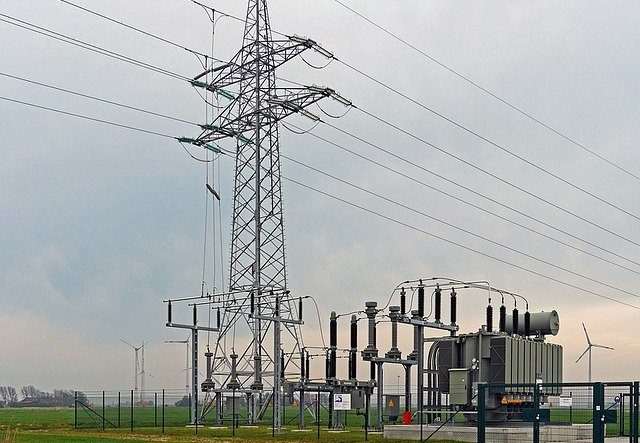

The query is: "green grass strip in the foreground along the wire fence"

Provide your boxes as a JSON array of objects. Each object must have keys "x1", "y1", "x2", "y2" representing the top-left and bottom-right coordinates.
[{"x1": 0, "y1": 406, "x2": 629, "y2": 443}]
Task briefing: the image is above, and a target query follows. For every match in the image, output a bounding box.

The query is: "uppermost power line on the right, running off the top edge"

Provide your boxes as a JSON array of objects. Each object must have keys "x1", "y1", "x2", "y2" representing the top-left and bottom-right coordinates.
[{"x1": 334, "y1": 0, "x2": 640, "y2": 180}]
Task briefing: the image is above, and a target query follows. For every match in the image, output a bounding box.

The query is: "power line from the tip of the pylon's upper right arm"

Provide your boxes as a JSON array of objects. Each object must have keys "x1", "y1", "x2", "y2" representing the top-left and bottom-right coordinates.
[{"x1": 337, "y1": 59, "x2": 640, "y2": 224}]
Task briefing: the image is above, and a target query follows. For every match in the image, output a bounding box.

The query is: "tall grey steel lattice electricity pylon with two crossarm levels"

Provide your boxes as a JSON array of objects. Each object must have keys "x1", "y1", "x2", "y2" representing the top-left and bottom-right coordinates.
[{"x1": 181, "y1": 0, "x2": 351, "y2": 429}]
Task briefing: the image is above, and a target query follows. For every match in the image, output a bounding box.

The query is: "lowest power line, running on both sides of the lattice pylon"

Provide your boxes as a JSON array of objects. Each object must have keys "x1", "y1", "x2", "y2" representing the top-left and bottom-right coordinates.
[{"x1": 0, "y1": 96, "x2": 640, "y2": 310}]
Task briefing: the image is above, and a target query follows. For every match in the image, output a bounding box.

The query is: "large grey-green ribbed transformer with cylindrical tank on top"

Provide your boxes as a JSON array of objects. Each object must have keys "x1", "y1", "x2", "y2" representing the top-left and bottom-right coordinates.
[{"x1": 427, "y1": 311, "x2": 562, "y2": 421}]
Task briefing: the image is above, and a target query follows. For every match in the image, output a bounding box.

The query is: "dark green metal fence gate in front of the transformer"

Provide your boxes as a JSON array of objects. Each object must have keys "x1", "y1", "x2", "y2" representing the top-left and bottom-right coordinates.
[{"x1": 477, "y1": 382, "x2": 640, "y2": 443}]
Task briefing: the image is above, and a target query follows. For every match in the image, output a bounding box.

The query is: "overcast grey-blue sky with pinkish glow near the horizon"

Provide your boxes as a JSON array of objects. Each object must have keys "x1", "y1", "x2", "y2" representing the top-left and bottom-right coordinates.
[{"x1": 0, "y1": 0, "x2": 640, "y2": 389}]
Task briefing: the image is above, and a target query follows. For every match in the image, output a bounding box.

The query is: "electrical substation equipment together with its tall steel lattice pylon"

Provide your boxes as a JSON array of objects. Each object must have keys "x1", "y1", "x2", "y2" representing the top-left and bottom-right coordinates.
[{"x1": 165, "y1": 0, "x2": 576, "y2": 439}]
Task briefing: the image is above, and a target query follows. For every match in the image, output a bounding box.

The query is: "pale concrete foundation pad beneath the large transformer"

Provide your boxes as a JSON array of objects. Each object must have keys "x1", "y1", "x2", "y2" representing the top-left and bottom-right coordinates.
[{"x1": 384, "y1": 424, "x2": 592, "y2": 443}]
